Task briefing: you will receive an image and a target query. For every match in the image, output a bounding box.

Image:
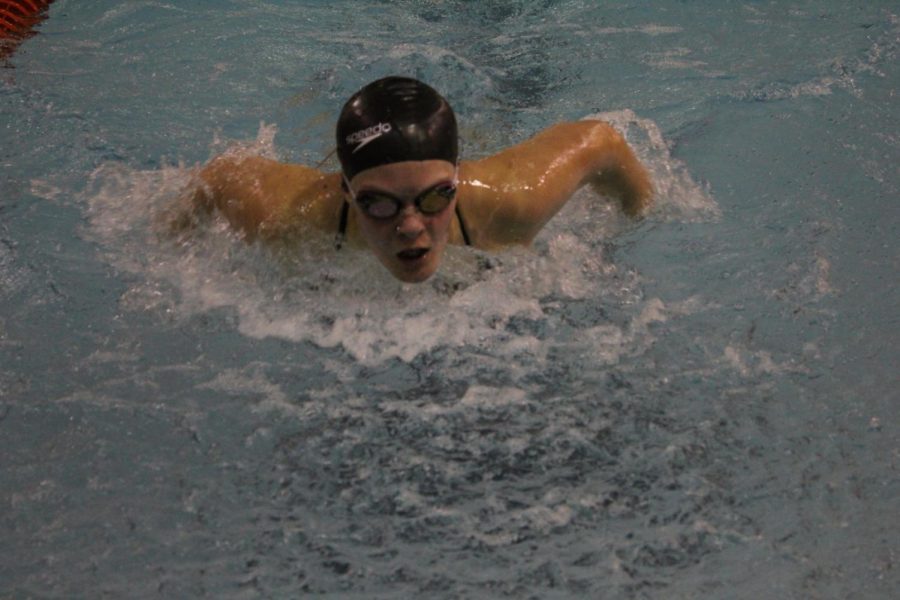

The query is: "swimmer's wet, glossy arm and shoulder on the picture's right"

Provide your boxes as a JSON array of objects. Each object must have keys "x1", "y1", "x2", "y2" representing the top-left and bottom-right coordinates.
[{"x1": 460, "y1": 121, "x2": 653, "y2": 247}]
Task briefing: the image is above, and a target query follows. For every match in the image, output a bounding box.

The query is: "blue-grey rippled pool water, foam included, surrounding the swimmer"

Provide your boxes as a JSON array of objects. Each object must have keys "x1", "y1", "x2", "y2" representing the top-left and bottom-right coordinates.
[{"x1": 0, "y1": 0, "x2": 900, "y2": 598}]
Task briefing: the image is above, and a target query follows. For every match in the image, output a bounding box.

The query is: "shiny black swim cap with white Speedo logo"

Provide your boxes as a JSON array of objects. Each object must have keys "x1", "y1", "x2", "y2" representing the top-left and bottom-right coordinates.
[{"x1": 336, "y1": 77, "x2": 458, "y2": 179}]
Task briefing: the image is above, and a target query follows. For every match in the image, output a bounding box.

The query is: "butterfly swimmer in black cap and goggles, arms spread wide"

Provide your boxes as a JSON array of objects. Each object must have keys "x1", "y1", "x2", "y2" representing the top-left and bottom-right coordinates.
[{"x1": 171, "y1": 77, "x2": 653, "y2": 283}]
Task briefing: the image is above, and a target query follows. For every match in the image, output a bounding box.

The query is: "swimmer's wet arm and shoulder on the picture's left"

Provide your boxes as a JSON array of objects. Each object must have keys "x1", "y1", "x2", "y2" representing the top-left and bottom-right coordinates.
[{"x1": 170, "y1": 155, "x2": 340, "y2": 240}]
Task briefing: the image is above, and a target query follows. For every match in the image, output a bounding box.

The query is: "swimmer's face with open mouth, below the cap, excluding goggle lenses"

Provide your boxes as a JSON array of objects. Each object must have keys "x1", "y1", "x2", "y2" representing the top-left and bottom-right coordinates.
[{"x1": 350, "y1": 160, "x2": 456, "y2": 283}]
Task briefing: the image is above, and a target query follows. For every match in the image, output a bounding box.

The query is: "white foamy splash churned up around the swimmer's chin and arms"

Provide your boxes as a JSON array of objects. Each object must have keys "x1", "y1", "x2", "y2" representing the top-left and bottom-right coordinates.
[{"x1": 86, "y1": 111, "x2": 718, "y2": 366}]
